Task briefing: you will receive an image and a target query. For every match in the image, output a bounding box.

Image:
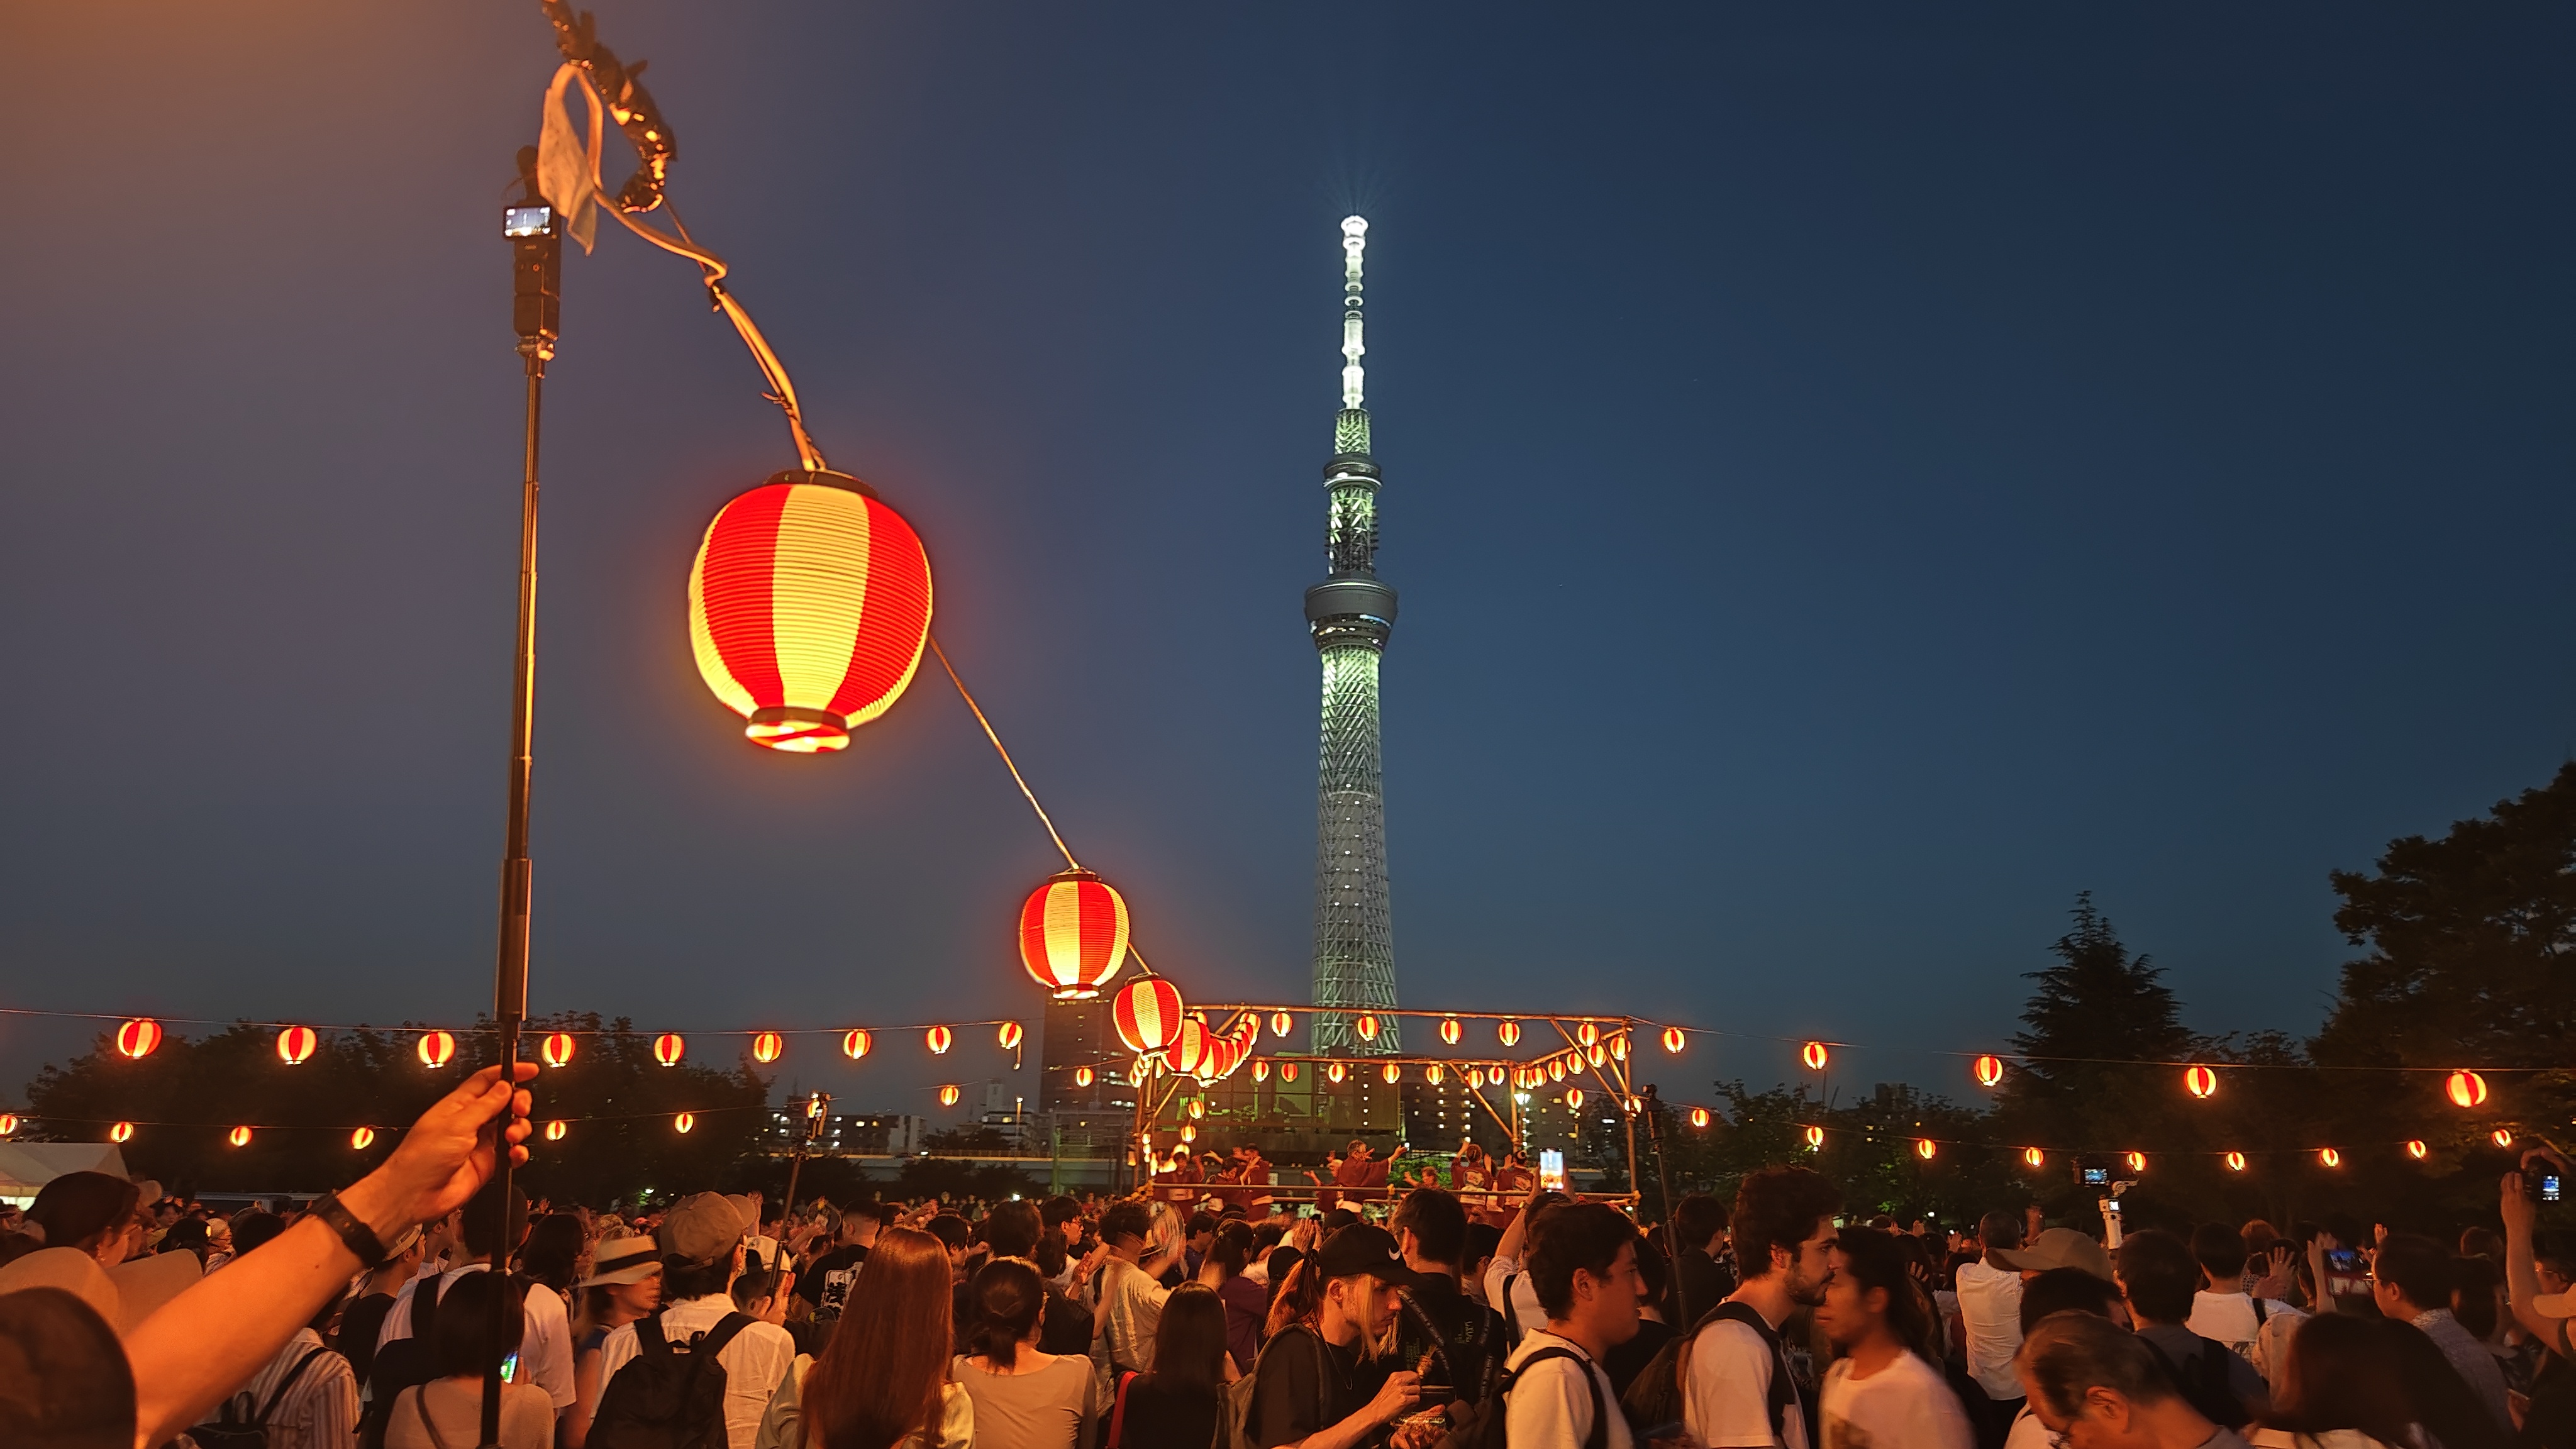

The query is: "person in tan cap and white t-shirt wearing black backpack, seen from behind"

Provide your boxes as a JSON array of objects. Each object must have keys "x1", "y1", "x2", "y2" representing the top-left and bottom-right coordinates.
[{"x1": 600, "y1": 1191, "x2": 796, "y2": 1449}]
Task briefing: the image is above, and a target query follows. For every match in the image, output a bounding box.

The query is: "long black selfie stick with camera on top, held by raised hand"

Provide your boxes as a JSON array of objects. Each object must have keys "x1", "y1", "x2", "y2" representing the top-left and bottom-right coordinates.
[{"x1": 479, "y1": 147, "x2": 564, "y2": 1449}]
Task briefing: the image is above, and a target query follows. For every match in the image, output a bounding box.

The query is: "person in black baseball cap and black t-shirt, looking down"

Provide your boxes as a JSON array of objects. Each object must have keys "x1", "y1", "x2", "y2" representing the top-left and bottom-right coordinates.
[{"x1": 1246, "y1": 1222, "x2": 1422, "y2": 1449}]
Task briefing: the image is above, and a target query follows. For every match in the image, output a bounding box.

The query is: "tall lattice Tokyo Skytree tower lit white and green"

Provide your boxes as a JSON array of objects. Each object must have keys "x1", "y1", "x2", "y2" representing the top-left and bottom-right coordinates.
[{"x1": 1306, "y1": 216, "x2": 1396, "y2": 1055}]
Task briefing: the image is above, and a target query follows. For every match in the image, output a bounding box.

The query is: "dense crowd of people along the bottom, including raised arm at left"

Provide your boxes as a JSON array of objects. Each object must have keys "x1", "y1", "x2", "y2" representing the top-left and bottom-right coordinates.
[{"x1": 0, "y1": 1070, "x2": 2576, "y2": 1449}]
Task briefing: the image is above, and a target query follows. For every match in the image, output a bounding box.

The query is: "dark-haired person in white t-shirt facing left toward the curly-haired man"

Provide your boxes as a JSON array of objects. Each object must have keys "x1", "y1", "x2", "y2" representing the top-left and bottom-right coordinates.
[{"x1": 1816, "y1": 1219, "x2": 1968, "y2": 1449}]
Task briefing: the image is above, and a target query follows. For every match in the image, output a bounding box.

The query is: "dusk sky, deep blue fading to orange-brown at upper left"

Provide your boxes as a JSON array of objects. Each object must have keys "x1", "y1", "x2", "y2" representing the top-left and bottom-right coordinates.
[{"x1": 0, "y1": 0, "x2": 2576, "y2": 1106}]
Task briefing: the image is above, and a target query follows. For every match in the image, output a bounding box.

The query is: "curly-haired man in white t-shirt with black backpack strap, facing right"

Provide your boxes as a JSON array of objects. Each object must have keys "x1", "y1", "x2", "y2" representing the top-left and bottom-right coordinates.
[{"x1": 1682, "y1": 1168, "x2": 1842, "y2": 1449}]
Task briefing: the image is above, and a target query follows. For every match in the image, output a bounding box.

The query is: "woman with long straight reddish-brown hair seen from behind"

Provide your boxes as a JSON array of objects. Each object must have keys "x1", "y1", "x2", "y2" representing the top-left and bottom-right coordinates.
[{"x1": 757, "y1": 1227, "x2": 974, "y2": 1449}]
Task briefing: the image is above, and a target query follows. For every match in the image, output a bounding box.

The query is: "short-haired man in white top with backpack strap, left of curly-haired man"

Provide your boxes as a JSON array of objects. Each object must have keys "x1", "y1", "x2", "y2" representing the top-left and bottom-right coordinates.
[{"x1": 1504, "y1": 1201, "x2": 1643, "y2": 1449}]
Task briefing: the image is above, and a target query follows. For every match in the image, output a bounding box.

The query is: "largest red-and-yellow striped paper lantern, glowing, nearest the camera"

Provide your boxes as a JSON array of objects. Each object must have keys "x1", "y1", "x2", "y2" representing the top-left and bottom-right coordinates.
[{"x1": 688, "y1": 469, "x2": 930, "y2": 755}]
